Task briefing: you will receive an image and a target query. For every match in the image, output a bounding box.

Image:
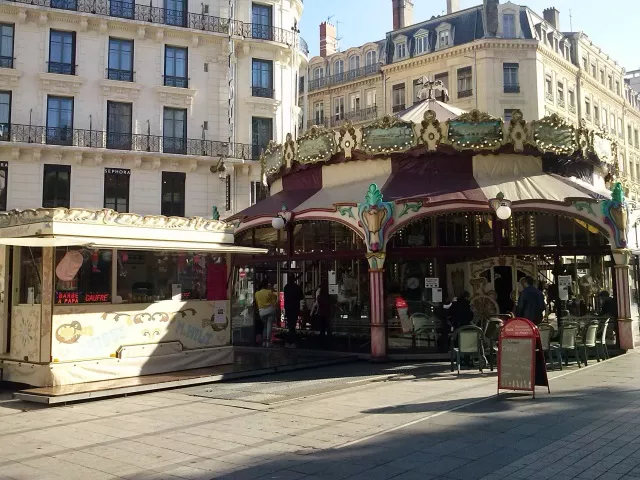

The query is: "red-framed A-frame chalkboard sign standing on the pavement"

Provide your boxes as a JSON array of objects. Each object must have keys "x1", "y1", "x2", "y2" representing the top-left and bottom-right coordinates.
[{"x1": 498, "y1": 318, "x2": 551, "y2": 398}]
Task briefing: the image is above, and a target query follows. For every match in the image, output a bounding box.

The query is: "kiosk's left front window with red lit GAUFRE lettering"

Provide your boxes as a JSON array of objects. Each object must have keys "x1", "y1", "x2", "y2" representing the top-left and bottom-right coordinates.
[{"x1": 54, "y1": 247, "x2": 113, "y2": 305}]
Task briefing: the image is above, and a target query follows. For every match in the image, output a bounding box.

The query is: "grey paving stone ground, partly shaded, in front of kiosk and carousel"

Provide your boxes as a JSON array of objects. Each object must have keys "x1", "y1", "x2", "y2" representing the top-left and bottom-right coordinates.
[{"x1": 0, "y1": 352, "x2": 640, "y2": 480}]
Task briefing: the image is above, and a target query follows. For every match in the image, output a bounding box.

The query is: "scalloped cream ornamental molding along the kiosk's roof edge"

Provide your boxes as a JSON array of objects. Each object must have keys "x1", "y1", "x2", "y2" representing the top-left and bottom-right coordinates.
[{"x1": 0, "y1": 208, "x2": 233, "y2": 233}]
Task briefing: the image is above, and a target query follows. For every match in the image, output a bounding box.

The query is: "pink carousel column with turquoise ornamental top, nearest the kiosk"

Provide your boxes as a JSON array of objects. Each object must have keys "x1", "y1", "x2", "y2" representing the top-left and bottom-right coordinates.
[{"x1": 358, "y1": 184, "x2": 393, "y2": 360}]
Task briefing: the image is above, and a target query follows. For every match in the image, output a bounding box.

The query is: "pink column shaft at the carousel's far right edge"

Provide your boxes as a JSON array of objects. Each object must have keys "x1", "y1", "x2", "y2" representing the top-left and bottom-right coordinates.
[{"x1": 613, "y1": 250, "x2": 640, "y2": 350}]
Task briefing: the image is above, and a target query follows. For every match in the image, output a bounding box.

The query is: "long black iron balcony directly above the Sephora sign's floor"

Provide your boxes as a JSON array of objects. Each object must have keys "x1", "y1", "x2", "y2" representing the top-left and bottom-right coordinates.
[{"x1": 0, "y1": 123, "x2": 252, "y2": 160}]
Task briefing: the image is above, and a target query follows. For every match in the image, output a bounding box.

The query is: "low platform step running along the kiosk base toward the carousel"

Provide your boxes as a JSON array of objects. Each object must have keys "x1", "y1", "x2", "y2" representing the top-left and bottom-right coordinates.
[{"x1": 14, "y1": 347, "x2": 358, "y2": 405}]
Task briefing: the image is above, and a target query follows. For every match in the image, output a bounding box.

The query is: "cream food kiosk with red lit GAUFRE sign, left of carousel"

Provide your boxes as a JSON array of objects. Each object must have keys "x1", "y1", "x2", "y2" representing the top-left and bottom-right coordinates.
[{"x1": 0, "y1": 208, "x2": 266, "y2": 386}]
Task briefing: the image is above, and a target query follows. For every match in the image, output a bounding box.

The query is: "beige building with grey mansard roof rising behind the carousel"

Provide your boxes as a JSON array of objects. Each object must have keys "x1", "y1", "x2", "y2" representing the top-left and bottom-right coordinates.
[{"x1": 300, "y1": 1, "x2": 640, "y2": 199}]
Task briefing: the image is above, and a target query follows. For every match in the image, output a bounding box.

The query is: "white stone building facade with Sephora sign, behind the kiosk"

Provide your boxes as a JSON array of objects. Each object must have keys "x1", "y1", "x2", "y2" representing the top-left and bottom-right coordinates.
[{"x1": 0, "y1": 0, "x2": 308, "y2": 218}]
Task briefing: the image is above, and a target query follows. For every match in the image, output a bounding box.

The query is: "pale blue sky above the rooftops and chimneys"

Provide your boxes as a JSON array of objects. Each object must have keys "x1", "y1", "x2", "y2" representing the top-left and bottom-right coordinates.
[{"x1": 300, "y1": 0, "x2": 640, "y2": 70}]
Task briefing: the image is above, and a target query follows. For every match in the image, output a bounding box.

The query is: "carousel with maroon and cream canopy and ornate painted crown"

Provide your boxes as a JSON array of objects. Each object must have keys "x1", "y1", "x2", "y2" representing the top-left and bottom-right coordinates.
[{"x1": 230, "y1": 81, "x2": 639, "y2": 357}]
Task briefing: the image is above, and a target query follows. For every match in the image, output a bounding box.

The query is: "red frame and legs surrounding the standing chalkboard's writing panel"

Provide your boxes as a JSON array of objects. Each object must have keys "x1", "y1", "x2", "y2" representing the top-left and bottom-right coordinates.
[{"x1": 498, "y1": 318, "x2": 551, "y2": 398}]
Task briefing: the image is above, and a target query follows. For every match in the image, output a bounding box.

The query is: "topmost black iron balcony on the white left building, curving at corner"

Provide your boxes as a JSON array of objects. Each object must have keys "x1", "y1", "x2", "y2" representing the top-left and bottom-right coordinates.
[{"x1": 8, "y1": 0, "x2": 309, "y2": 51}]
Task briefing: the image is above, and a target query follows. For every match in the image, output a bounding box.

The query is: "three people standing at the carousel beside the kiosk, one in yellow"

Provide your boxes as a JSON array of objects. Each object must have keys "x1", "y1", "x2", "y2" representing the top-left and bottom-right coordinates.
[{"x1": 254, "y1": 276, "x2": 330, "y2": 348}]
